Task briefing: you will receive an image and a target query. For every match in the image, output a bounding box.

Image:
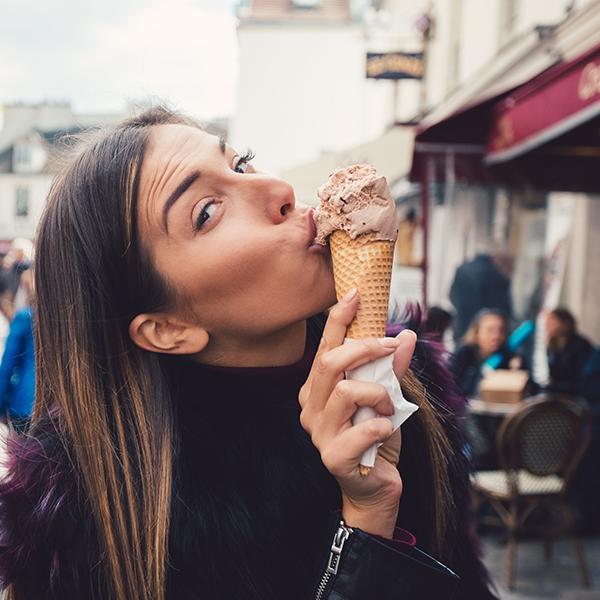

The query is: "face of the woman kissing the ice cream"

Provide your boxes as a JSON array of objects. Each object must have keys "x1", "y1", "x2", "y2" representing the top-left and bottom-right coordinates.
[{"x1": 138, "y1": 125, "x2": 335, "y2": 338}]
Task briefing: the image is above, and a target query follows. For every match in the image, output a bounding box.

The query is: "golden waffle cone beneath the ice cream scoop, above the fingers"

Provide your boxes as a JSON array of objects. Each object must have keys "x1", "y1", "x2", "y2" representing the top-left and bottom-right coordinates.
[{"x1": 329, "y1": 231, "x2": 394, "y2": 339}]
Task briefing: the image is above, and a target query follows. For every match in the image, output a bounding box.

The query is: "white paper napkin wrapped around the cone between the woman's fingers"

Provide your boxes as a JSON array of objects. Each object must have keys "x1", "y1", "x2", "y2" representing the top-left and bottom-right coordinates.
[{"x1": 344, "y1": 338, "x2": 419, "y2": 467}]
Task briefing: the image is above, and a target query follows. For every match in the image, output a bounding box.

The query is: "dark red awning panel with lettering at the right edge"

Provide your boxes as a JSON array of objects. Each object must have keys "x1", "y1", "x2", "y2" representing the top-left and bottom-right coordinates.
[{"x1": 484, "y1": 45, "x2": 600, "y2": 165}]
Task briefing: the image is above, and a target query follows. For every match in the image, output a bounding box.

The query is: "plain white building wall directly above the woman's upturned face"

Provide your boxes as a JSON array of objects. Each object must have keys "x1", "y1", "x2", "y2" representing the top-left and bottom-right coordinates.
[{"x1": 230, "y1": 0, "x2": 406, "y2": 174}]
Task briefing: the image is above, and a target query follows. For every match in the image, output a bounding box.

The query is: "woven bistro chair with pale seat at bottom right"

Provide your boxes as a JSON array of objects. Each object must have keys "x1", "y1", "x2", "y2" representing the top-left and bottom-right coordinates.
[{"x1": 472, "y1": 397, "x2": 590, "y2": 589}]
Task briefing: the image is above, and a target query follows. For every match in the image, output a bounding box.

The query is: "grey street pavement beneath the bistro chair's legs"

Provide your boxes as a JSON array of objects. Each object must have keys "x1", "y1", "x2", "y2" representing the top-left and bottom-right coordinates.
[{"x1": 482, "y1": 536, "x2": 600, "y2": 600}]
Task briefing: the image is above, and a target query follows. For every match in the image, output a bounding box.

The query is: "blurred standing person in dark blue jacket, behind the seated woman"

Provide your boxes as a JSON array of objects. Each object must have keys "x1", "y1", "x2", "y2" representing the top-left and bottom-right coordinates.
[{"x1": 450, "y1": 253, "x2": 512, "y2": 345}]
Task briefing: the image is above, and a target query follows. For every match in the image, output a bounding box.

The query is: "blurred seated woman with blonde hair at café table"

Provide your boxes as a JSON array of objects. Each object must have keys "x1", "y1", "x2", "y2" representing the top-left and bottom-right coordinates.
[{"x1": 450, "y1": 308, "x2": 523, "y2": 398}]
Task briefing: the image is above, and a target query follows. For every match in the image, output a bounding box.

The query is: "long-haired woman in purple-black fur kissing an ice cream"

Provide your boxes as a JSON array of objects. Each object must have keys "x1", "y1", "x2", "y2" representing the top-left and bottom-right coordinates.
[{"x1": 0, "y1": 109, "x2": 492, "y2": 600}]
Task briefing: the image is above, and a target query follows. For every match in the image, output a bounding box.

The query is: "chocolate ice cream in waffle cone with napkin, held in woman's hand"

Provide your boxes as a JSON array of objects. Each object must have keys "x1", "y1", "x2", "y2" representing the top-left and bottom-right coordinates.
[{"x1": 315, "y1": 164, "x2": 401, "y2": 477}]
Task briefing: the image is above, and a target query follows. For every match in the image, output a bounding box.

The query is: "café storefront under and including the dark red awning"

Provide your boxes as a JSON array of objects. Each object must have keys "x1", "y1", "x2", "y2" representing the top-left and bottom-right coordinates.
[{"x1": 411, "y1": 16, "x2": 600, "y2": 343}]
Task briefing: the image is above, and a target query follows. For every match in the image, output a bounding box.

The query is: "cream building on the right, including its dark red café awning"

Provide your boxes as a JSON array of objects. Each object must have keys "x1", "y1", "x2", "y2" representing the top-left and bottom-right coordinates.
[{"x1": 413, "y1": 0, "x2": 600, "y2": 352}]
